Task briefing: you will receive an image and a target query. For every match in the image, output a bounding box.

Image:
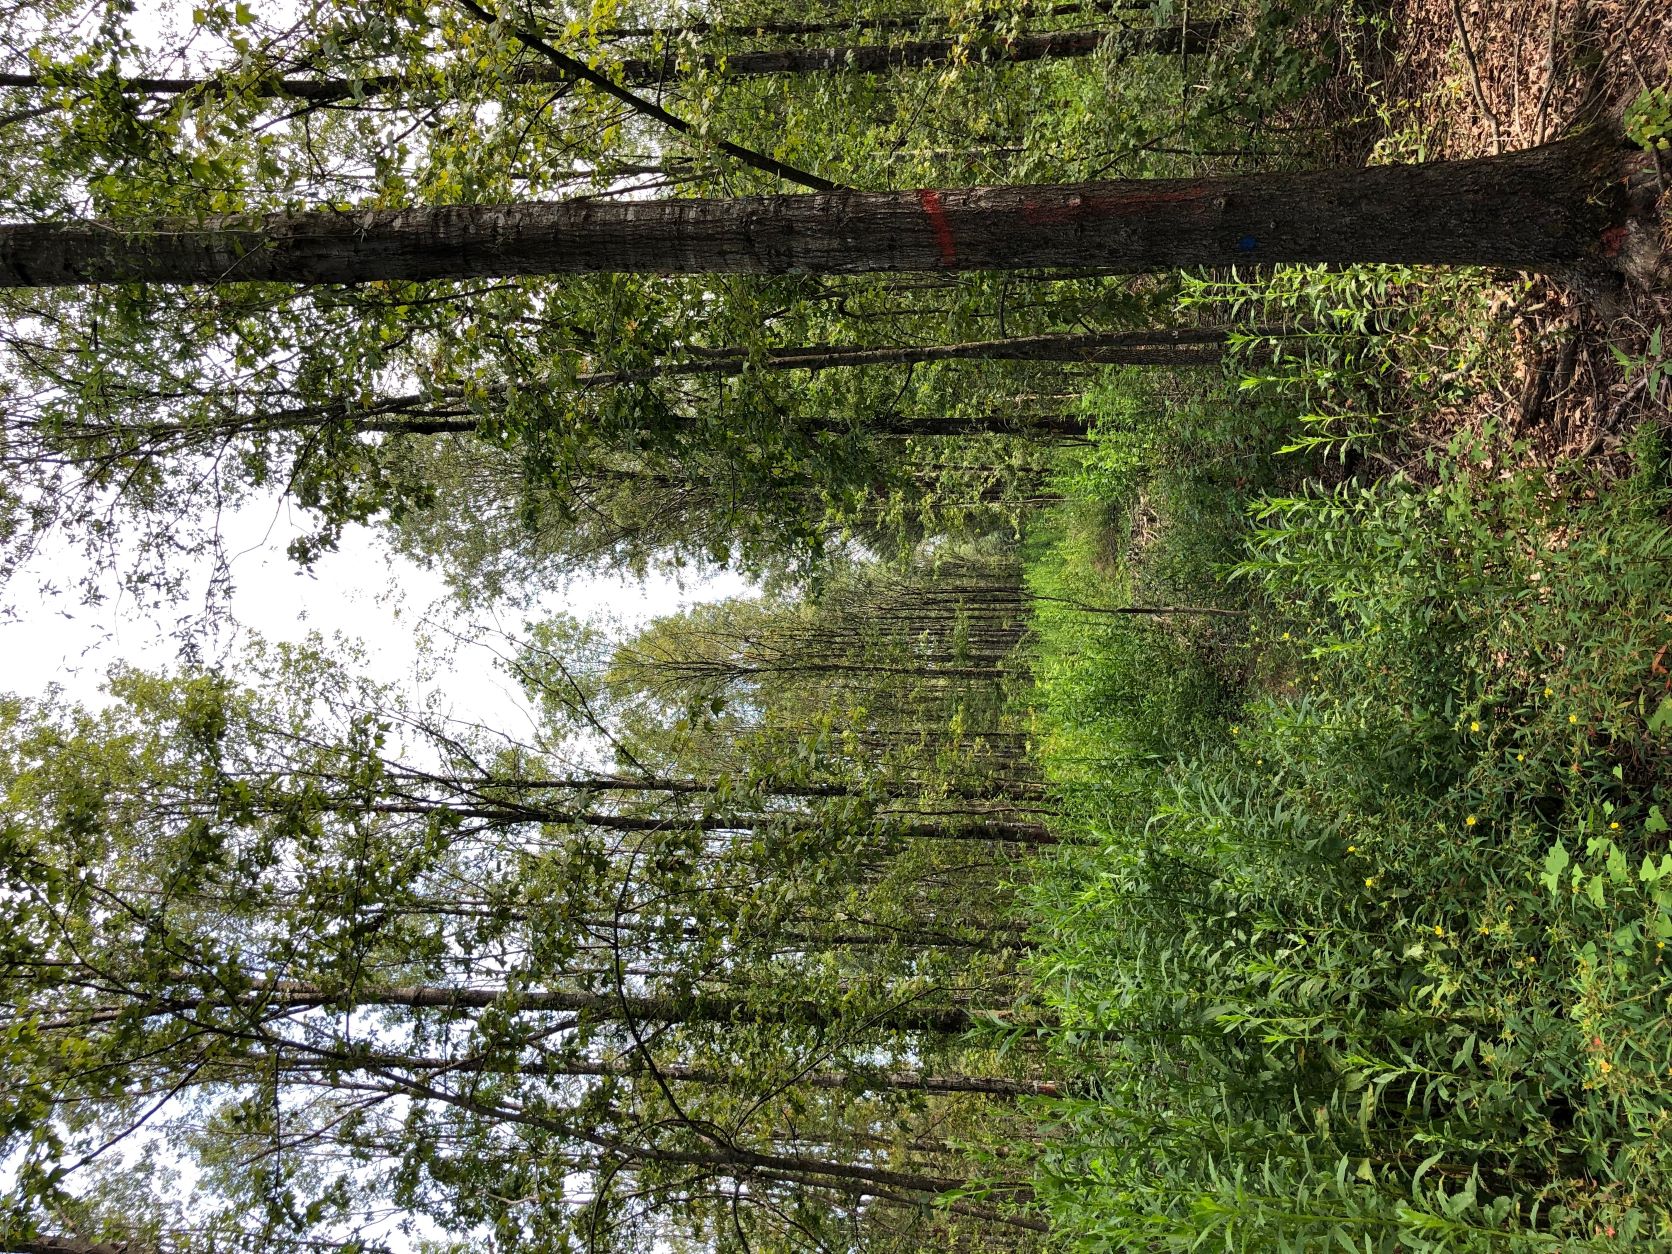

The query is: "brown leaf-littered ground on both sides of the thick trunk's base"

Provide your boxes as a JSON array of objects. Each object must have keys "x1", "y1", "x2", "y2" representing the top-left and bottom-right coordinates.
[{"x1": 1376, "y1": 0, "x2": 1672, "y2": 468}]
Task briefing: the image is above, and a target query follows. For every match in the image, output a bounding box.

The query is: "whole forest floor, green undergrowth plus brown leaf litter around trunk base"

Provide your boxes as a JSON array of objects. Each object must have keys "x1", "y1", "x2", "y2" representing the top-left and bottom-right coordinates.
[{"x1": 1003, "y1": 0, "x2": 1672, "y2": 1254}]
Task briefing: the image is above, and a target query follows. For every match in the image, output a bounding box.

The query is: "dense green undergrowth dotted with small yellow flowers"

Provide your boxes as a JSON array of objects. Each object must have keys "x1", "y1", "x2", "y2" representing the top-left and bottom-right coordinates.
[{"x1": 1009, "y1": 362, "x2": 1672, "y2": 1251}]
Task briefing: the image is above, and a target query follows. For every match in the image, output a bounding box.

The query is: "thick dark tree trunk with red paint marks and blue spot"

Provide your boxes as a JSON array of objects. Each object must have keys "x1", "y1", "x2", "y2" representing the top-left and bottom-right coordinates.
[{"x1": 0, "y1": 137, "x2": 1629, "y2": 288}]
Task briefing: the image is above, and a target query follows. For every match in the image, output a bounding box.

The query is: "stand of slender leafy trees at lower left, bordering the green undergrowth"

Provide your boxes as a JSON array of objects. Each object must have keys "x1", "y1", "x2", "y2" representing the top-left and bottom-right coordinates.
[{"x1": 3, "y1": 553, "x2": 1083, "y2": 1249}]
